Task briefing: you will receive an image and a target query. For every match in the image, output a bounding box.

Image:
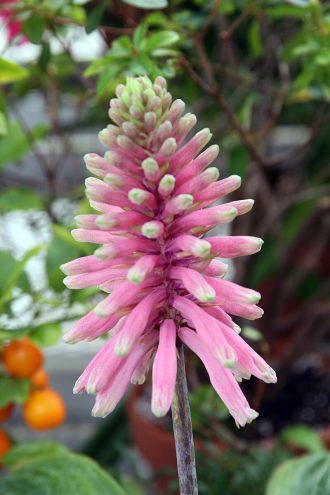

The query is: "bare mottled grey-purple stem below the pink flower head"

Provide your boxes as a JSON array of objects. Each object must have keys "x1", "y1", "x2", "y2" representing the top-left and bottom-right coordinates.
[{"x1": 172, "y1": 345, "x2": 198, "y2": 495}]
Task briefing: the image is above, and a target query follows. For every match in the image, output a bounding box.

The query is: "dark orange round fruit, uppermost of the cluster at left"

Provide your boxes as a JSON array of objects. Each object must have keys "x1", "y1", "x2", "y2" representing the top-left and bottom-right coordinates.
[{"x1": 2, "y1": 337, "x2": 43, "y2": 378}]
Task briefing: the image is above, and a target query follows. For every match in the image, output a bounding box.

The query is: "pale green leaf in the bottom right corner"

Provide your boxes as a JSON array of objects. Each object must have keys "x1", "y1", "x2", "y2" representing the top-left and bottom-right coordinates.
[{"x1": 266, "y1": 452, "x2": 330, "y2": 495}]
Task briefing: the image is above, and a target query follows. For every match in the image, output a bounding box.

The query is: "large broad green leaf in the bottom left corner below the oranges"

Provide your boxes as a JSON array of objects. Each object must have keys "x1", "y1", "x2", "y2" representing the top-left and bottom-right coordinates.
[{"x1": 0, "y1": 442, "x2": 125, "y2": 495}]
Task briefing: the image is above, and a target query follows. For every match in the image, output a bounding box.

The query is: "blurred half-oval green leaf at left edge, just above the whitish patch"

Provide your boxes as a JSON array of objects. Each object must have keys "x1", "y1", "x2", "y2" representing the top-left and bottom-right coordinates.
[{"x1": 0, "y1": 187, "x2": 43, "y2": 212}]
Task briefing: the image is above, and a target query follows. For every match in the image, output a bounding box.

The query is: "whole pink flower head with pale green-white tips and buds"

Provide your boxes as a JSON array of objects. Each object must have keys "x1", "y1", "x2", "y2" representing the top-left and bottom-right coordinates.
[{"x1": 62, "y1": 77, "x2": 276, "y2": 426}]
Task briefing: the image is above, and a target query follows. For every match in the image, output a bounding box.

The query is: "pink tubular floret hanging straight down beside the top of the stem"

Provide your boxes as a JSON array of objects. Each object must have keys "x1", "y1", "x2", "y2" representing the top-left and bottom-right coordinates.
[{"x1": 151, "y1": 320, "x2": 177, "y2": 417}]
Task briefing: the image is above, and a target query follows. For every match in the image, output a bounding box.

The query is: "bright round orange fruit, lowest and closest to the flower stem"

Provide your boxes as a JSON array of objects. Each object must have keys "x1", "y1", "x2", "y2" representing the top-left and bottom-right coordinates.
[{"x1": 22, "y1": 388, "x2": 66, "y2": 431}]
